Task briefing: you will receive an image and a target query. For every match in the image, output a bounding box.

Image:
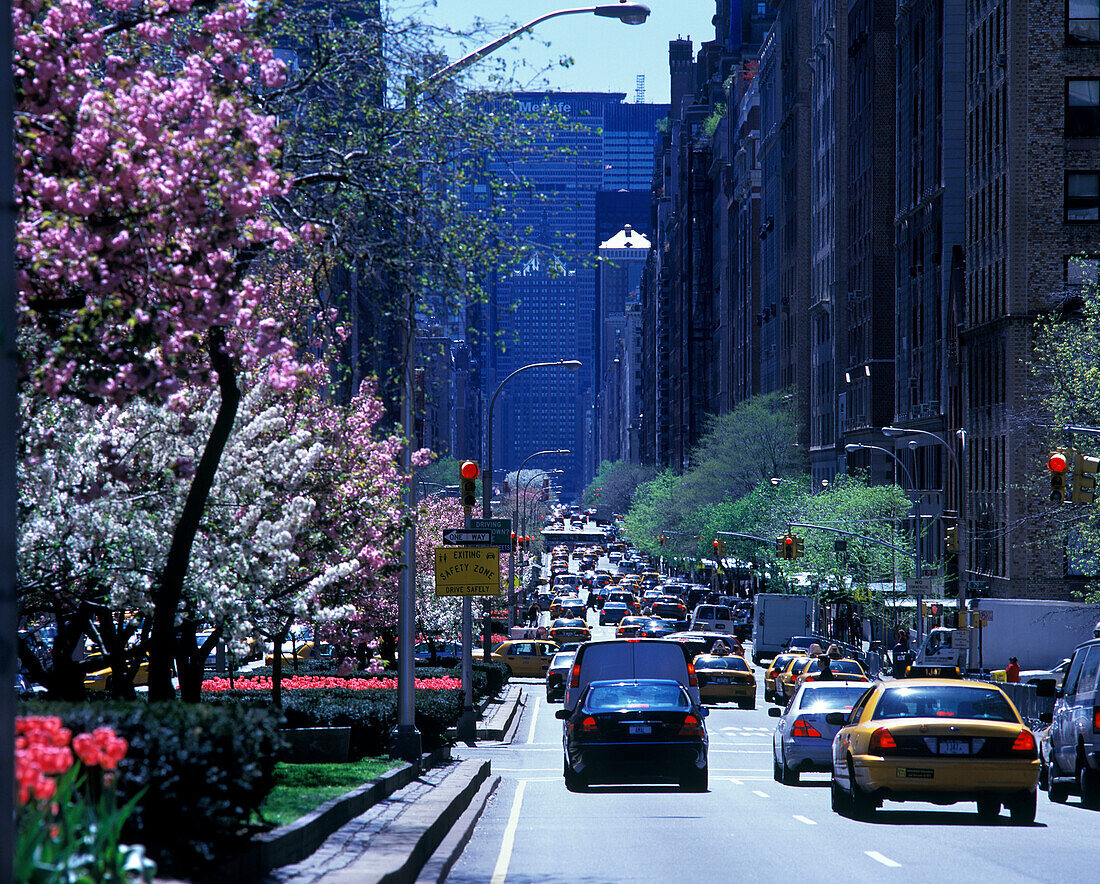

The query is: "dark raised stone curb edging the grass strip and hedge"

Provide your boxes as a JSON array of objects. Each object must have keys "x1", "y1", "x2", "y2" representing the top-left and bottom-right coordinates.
[{"x1": 196, "y1": 747, "x2": 451, "y2": 884}]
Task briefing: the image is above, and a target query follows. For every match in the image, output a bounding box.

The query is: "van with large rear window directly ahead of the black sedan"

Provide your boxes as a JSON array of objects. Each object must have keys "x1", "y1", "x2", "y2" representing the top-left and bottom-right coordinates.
[{"x1": 564, "y1": 639, "x2": 700, "y2": 709}]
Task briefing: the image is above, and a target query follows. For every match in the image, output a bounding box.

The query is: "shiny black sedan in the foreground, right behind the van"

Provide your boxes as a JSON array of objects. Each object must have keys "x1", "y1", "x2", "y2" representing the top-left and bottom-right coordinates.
[{"x1": 557, "y1": 678, "x2": 708, "y2": 792}]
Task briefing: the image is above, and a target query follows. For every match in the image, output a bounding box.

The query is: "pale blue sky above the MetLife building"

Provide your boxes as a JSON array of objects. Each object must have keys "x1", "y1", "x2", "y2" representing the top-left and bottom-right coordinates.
[{"x1": 409, "y1": 0, "x2": 715, "y2": 102}]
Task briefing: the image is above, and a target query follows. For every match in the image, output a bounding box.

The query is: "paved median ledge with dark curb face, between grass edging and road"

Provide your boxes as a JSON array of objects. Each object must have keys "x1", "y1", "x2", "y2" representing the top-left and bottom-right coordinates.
[{"x1": 326, "y1": 759, "x2": 491, "y2": 884}]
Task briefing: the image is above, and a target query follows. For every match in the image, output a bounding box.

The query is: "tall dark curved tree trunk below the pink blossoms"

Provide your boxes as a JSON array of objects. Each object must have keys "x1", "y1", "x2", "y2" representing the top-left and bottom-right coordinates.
[{"x1": 149, "y1": 328, "x2": 241, "y2": 700}]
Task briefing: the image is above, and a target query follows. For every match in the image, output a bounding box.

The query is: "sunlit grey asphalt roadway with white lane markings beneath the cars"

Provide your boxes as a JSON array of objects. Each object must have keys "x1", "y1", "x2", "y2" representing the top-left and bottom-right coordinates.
[{"x1": 447, "y1": 534, "x2": 1100, "y2": 884}]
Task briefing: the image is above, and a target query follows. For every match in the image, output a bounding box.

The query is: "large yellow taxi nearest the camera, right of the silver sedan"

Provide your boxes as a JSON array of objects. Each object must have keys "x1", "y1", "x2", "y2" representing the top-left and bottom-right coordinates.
[{"x1": 825, "y1": 678, "x2": 1040, "y2": 824}]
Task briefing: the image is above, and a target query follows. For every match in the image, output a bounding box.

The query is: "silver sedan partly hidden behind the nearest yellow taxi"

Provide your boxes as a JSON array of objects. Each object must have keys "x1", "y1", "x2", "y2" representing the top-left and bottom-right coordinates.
[{"x1": 768, "y1": 682, "x2": 870, "y2": 786}]
